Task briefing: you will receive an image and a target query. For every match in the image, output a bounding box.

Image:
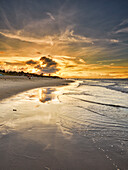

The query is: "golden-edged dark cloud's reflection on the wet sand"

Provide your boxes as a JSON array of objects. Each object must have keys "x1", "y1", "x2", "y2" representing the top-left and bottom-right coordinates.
[{"x1": 39, "y1": 88, "x2": 56, "y2": 103}]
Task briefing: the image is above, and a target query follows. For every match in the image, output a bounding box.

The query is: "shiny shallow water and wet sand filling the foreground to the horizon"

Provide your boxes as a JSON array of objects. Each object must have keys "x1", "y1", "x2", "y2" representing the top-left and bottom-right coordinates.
[{"x1": 0, "y1": 79, "x2": 128, "y2": 170}]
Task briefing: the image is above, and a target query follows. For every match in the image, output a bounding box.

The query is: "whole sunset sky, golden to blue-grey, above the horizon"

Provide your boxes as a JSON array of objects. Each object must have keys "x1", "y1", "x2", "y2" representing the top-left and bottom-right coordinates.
[{"x1": 0, "y1": 0, "x2": 128, "y2": 78}]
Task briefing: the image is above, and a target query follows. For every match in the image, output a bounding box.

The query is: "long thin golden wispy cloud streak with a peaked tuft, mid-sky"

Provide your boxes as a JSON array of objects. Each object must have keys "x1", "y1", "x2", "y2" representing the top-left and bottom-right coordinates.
[{"x1": 0, "y1": 29, "x2": 97, "y2": 45}]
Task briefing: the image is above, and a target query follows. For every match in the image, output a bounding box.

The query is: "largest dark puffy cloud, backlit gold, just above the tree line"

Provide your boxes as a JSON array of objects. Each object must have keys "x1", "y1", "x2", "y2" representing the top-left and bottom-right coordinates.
[{"x1": 35, "y1": 56, "x2": 59, "y2": 73}]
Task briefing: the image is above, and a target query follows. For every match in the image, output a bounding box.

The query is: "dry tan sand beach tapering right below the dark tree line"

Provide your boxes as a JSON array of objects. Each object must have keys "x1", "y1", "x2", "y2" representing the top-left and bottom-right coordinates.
[{"x1": 0, "y1": 76, "x2": 73, "y2": 101}]
